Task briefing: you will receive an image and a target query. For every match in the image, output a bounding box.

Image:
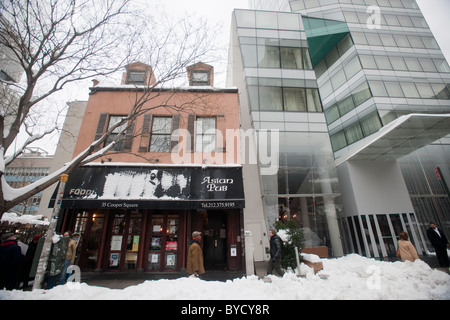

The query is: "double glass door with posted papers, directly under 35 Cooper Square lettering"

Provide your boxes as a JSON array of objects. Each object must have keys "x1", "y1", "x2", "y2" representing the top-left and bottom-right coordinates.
[{"x1": 106, "y1": 210, "x2": 142, "y2": 271}]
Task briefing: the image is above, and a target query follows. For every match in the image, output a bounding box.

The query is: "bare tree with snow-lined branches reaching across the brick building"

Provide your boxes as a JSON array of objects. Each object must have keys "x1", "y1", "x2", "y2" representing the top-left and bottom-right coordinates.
[{"x1": 0, "y1": 0, "x2": 221, "y2": 215}]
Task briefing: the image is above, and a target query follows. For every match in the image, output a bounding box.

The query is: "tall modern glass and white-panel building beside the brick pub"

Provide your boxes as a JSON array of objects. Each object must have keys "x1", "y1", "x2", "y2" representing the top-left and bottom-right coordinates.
[{"x1": 227, "y1": 0, "x2": 450, "y2": 258}]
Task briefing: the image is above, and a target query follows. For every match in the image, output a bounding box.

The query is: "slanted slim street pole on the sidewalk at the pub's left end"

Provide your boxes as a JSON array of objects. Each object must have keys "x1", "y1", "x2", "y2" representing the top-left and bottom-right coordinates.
[{"x1": 33, "y1": 174, "x2": 69, "y2": 290}]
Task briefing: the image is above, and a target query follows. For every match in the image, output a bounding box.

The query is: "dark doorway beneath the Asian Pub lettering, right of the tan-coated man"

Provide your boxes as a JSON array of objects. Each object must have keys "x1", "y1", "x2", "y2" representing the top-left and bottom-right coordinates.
[{"x1": 203, "y1": 212, "x2": 227, "y2": 270}]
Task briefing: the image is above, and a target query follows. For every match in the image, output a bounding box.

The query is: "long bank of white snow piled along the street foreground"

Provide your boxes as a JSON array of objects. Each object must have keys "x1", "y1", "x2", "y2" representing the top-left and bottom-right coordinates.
[{"x1": 0, "y1": 254, "x2": 450, "y2": 300}]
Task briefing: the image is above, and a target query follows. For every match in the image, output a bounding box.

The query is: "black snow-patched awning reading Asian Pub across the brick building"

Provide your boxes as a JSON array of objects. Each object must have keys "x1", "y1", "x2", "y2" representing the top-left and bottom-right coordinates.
[{"x1": 61, "y1": 165, "x2": 244, "y2": 209}]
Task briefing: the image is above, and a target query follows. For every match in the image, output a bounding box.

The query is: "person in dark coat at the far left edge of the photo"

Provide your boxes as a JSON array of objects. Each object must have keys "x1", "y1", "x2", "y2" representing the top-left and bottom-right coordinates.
[{"x1": 0, "y1": 233, "x2": 23, "y2": 290}]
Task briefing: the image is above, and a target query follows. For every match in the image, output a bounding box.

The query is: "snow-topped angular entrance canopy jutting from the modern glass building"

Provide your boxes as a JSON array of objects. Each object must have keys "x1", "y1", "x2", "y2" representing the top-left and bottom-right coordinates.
[{"x1": 336, "y1": 114, "x2": 450, "y2": 166}]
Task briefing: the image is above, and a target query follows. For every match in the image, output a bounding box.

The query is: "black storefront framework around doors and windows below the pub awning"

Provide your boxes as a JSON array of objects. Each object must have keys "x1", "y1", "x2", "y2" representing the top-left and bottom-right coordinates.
[{"x1": 63, "y1": 209, "x2": 245, "y2": 273}]
